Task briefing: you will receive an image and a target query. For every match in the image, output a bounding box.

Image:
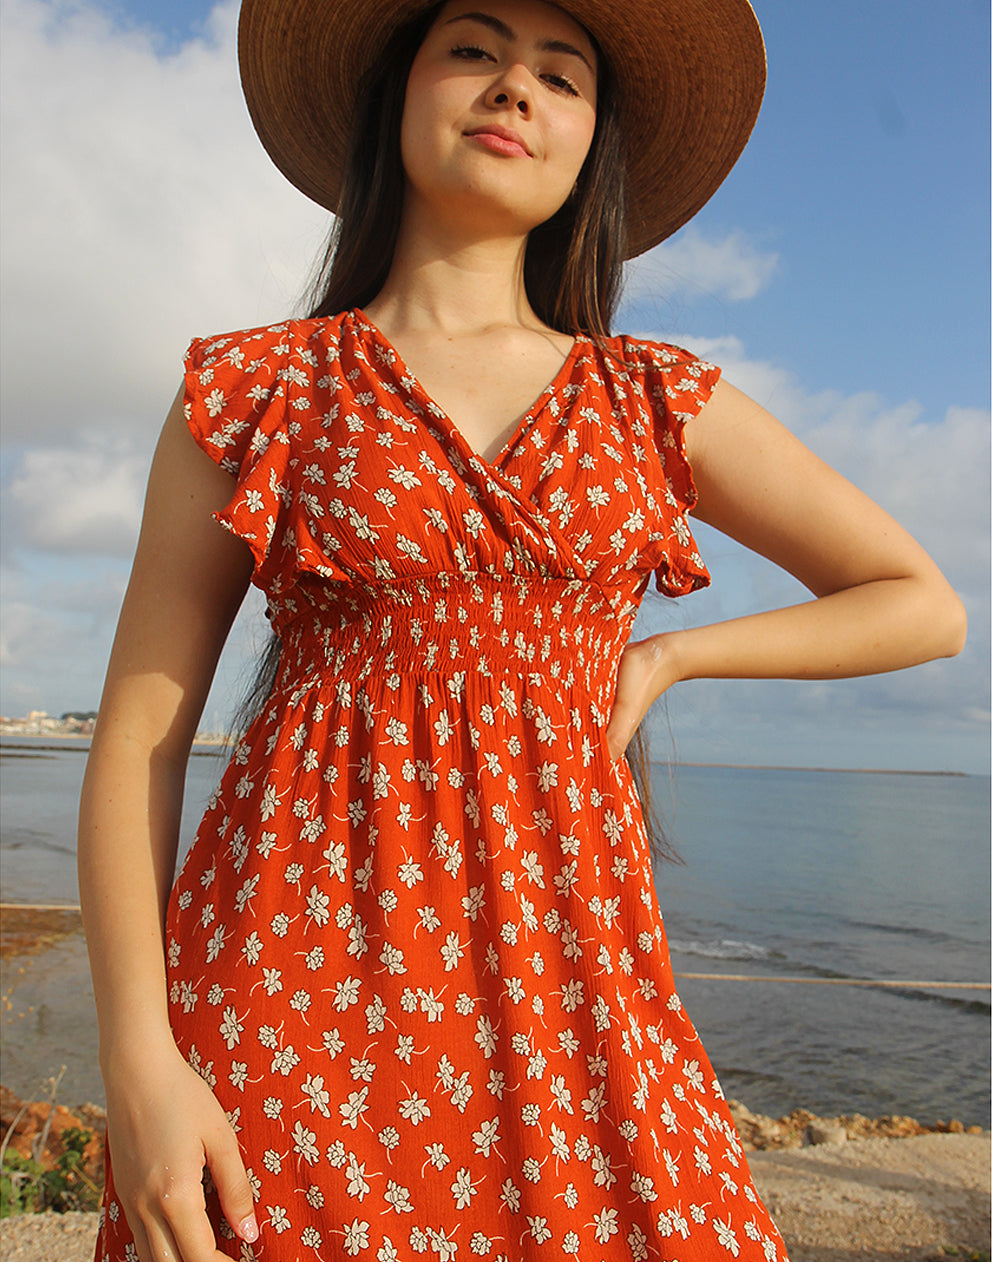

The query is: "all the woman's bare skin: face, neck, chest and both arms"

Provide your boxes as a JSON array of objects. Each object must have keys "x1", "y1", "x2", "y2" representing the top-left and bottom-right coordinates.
[{"x1": 80, "y1": 0, "x2": 964, "y2": 1262}]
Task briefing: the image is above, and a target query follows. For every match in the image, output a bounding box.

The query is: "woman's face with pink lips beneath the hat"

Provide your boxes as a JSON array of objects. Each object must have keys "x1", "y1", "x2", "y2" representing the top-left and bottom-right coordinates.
[{"x1": 401, "y1": 0, "x2": 596, "y2": 233}]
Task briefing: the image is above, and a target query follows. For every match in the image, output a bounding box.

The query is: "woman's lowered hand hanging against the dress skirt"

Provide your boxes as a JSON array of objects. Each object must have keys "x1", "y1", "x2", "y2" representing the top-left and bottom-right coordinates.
[{"x1": 107, "y1": 1045, "x2": 259, "y2": 1262}]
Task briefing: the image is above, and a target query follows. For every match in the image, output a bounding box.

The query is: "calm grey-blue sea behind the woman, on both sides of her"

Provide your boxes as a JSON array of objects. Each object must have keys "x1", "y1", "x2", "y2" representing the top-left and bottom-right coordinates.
[{"x1": 0, "y1": 738, "x2": 991, "y2": 1127}]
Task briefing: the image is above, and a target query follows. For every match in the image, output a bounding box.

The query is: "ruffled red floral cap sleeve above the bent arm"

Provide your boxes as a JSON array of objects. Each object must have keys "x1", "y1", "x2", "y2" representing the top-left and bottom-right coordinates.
[{"x1": 631, "y1": 342, "x2": 719, "y2": 596}]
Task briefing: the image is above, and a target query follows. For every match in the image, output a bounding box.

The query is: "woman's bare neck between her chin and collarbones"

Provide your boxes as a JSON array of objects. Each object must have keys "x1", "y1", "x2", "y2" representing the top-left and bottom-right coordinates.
[{"x1": 365, "y1": 198, "x2": 544, "y2": 336}]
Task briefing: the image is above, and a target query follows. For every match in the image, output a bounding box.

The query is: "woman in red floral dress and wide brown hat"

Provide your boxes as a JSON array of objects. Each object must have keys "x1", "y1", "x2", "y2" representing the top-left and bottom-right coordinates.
[{"x1": 80, "y1": 0, "x2": 964, "y2": 1262}]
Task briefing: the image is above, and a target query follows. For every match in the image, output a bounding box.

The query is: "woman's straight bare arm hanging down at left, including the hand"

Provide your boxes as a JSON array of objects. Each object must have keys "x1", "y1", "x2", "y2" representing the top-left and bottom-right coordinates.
[{"x1": 78, "y1": 391, "x2": 257, "y2": 1262}]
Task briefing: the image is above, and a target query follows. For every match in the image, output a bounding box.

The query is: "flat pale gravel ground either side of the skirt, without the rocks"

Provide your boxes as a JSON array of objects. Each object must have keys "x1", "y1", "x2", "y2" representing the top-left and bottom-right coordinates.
[{"x1": 0, "y1": 1135, "x2": 989, "y2": 1262}]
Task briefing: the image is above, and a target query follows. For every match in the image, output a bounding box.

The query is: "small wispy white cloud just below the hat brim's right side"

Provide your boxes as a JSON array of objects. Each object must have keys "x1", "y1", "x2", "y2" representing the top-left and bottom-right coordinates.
[{"x1": 623, "y1": 225, "x2": 779, "y2": 302}]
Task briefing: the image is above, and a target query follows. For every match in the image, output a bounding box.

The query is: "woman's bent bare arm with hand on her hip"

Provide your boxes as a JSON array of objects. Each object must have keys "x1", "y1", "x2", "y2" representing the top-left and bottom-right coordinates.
[{"x1": 607, "y1": 381, "x2": 965, "y2": 758}]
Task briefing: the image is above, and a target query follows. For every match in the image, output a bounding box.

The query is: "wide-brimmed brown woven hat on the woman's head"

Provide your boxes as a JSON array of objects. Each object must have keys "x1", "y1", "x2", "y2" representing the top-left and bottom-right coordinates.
[{"x1": 239, "y1": 0, "x2": 765, "y2": 257}]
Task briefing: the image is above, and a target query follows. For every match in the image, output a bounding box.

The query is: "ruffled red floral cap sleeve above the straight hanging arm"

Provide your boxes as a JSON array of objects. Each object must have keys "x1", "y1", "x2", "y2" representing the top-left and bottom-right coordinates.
[{"x1": 184, "y1": 326, "x2": 293, "y2": 591}]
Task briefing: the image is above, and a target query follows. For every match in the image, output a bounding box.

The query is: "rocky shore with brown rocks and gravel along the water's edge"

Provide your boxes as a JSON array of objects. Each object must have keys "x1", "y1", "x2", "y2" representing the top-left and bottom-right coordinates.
[{"x1": 0, "y1": 1088, "x2": 991, "y2": 1262}]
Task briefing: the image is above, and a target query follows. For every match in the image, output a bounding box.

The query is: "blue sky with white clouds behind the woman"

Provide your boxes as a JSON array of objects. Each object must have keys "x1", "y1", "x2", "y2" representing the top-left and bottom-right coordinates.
[{"x1": 0, "y1": 0, "x2": 989, "y2": 774}]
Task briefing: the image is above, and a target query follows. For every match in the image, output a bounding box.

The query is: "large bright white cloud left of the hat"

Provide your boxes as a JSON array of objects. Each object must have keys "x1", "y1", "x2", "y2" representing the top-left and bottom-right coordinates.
[{"x1": 0, "y1": 0, "x2": 328, "y2": 443}]
